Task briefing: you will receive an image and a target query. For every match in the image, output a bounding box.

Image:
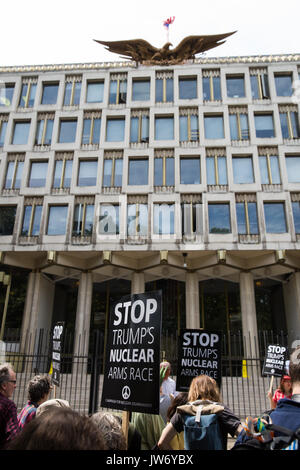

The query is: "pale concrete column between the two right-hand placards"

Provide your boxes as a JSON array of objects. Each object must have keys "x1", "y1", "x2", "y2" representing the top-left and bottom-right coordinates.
[{"x1": 240, "y1": 273, "x2": 259, "y2": 358}]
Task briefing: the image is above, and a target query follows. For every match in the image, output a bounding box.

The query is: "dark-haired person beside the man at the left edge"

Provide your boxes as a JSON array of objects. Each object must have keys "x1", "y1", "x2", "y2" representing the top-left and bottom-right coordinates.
[{"x1": 18, "y1": 375, "x2": 51, "y2": 429}]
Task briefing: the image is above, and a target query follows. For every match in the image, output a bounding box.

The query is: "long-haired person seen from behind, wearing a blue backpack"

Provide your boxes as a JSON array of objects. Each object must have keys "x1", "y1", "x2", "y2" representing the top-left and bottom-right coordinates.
[{"x1": 158, "y1": 375, "x2": 242, "y2": 450}]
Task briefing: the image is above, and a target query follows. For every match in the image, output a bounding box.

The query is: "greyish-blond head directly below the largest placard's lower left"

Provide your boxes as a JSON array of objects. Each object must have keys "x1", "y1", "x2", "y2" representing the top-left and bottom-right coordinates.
[{"x1": 90, "y1": 411, "x2": 126, "y2": 450}]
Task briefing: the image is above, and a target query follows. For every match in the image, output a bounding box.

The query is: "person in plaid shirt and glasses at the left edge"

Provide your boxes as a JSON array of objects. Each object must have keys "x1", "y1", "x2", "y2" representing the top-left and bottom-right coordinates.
[{"x1": 0, "y1": 364, "x2": 19, "y2": 449}]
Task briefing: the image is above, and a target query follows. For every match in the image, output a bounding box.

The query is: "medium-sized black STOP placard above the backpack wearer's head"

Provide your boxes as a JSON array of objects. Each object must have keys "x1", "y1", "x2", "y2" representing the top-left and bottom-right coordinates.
[{"x1": 176, "y1": 330, "x2": 222, "y2": 392}]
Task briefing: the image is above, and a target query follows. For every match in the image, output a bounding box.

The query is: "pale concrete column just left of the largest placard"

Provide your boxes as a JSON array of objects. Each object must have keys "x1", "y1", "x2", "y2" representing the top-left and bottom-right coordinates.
[{"x1": 74, "y1": 272, "x2": 93, "y2": 355}]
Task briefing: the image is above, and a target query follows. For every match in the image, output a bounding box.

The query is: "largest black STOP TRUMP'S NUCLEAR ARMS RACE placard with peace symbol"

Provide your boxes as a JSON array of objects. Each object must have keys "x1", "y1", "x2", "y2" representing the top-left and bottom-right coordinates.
[{"x1": 101, "y1": 291, "x2": 162, "y2": 414}]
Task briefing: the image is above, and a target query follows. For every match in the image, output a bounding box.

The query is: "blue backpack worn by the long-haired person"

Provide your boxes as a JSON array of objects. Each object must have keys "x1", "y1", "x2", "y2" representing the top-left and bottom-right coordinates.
[{"x1": 177, "y1": 400, "x2": 224, "y2": 450}]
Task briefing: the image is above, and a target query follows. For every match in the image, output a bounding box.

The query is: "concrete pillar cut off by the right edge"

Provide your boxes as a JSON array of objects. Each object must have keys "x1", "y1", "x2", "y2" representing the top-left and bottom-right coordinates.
[{"x1": 283, "y1": 272, "x2": 300, "y2": 347}]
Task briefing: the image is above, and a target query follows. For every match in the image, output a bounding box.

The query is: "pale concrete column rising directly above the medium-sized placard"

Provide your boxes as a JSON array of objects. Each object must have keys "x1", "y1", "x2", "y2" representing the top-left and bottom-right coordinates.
[{"x1": 185, "y1": 272, "x2": 200, "y2": 329}]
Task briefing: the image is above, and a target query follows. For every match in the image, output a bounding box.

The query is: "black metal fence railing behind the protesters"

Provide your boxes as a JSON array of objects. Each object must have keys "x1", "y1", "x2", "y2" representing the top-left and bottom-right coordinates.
[{"x1": 0, "y1": 330, "x2": 298, "y2": 418}]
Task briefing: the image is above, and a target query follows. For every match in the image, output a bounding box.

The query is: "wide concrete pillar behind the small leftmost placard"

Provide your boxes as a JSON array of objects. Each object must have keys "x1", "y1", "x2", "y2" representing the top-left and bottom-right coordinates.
[{"x1": 21, "y1": 271, "x2": 55, "y2": 353}]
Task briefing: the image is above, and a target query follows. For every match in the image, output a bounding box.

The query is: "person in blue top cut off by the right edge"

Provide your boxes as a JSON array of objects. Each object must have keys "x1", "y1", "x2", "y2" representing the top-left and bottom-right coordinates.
[{"x1": 270, "y1": 346, "x2": 300, "y2": 431}]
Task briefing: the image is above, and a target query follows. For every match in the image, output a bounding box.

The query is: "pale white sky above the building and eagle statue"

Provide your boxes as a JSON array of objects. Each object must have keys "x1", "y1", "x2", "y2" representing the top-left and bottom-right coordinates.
[{"x1": 0, "y1": 0, "x2": 300, "y2": 66}]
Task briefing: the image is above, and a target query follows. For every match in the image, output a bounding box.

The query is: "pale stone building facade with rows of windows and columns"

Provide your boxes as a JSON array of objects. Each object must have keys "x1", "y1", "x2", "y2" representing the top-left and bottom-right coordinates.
[{"x1": 0, "y1": 55, "x2": 300, "y2": 356}]
